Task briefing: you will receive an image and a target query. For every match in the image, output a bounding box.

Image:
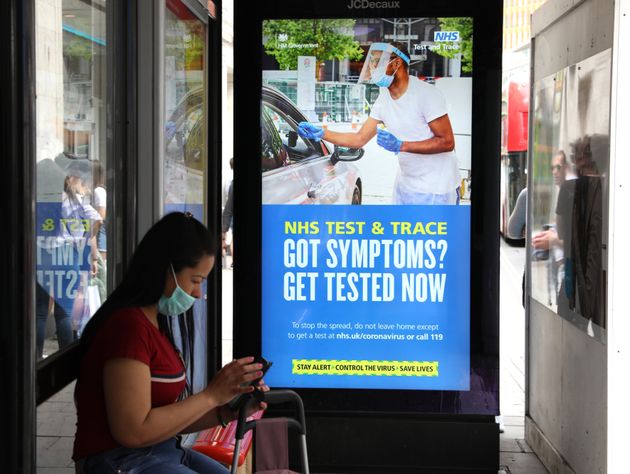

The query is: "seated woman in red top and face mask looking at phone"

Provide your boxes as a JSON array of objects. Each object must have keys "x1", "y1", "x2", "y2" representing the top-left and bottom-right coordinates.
[{"x1": 73, "y1": 213, "x2": 267, "y2": 474}]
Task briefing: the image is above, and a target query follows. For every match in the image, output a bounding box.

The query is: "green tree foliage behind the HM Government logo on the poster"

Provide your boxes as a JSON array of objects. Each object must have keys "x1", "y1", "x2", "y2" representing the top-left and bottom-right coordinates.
[{"x1": 263, "y1": 19, "x2": 363, "y2": 71}]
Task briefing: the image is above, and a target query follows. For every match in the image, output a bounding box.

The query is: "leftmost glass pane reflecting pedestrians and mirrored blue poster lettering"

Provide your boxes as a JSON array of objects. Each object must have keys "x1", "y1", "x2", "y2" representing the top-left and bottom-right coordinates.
[{"x1": 36, "y1": 0, "x2": 107, "y2": 359}]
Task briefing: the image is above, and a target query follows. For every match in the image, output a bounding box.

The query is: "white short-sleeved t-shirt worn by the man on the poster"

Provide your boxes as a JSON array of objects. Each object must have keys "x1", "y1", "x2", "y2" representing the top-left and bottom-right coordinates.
[{"x1": 370, "y1": 76, "x2": 460, "y2": 194}]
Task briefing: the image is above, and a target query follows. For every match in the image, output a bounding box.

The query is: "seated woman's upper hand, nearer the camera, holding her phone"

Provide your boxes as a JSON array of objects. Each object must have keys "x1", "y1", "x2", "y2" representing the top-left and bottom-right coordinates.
[{"x1": 204, "y1": 357, "x2": 263, "y2": 406}]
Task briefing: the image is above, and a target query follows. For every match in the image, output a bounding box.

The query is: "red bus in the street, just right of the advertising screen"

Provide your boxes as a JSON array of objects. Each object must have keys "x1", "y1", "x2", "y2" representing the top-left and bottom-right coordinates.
[{"x1": 500, "y1": 74, "x2": 529, "y2": 245}]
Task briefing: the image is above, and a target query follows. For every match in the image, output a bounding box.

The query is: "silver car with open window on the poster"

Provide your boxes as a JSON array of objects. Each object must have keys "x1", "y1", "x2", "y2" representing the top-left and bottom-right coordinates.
[{"x1": 260, "y1": 87, "x2": 363, "y2": 204}]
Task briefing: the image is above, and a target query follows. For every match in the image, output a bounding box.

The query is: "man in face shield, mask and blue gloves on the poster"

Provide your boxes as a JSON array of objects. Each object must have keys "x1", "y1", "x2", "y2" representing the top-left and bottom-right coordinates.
[{"x1": 298, "y1": 42, "x2": 460, "y2": 204}]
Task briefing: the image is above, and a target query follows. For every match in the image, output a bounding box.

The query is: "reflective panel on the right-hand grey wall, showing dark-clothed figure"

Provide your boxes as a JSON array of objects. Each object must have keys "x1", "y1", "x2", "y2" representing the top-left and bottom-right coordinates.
[{"x1": 531, "y1": 47, "x2": 610, "y2": 335}]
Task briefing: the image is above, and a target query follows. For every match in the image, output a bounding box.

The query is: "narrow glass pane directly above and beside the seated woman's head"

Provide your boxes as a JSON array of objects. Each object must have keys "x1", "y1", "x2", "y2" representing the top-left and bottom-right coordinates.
[{"x1": 163, "y1": 0, "x2": 209, "y2": 391}]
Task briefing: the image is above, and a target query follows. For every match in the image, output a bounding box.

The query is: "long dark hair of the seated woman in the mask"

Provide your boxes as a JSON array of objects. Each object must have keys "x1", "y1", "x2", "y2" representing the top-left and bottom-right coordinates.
[{"x1": 80, "y1": 212, "x2": 216, "y2": 374}]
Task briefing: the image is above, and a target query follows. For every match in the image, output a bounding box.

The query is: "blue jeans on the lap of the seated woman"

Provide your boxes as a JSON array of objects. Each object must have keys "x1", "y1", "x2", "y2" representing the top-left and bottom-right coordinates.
[{"x1": 83, "y1": 438, "x2": 229, "y2": 474}]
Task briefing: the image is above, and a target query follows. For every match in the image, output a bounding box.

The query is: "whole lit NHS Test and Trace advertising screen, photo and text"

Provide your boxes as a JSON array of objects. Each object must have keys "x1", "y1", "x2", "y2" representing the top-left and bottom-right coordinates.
[{"x1": 260, "y1": 17, "x2": 473, "y2": 391}]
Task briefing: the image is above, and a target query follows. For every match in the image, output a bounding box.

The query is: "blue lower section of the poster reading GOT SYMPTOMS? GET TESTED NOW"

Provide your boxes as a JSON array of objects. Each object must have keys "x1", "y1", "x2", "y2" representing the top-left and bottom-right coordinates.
[{"x1": 262, "y1": 205, "x2": 470, "y2": 390}]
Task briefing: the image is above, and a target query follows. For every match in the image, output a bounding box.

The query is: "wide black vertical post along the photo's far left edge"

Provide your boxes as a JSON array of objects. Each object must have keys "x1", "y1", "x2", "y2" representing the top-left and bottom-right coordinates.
[{"x1": 0, "y1": 0, "x2": 35, "y2": 473}]
